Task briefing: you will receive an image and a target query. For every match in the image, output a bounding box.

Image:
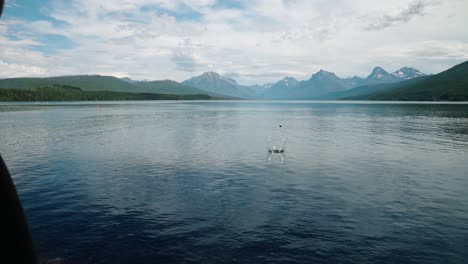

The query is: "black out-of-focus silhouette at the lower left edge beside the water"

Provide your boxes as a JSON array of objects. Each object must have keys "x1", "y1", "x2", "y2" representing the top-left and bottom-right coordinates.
[{"x1": 0, "y1": 156, "x2": 37, "y2": 263}]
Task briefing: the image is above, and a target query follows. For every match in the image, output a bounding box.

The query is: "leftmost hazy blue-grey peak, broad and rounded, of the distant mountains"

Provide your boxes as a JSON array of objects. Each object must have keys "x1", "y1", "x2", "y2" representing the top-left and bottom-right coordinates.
[{"x1": 182, "y1": 72, "x2": 255, "y2": 98}]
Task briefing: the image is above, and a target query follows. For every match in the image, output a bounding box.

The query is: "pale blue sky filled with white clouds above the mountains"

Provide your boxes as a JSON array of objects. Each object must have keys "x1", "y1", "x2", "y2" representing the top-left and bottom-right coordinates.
[{"x1": 0, "y1": 0, "x2": 468, "y2": 84}]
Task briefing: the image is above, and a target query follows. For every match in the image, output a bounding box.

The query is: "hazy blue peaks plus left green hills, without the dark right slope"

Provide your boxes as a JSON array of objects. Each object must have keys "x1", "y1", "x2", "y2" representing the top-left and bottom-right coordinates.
[{"x1": 0, "y1": 66, "x2": 438, "y2": 99}]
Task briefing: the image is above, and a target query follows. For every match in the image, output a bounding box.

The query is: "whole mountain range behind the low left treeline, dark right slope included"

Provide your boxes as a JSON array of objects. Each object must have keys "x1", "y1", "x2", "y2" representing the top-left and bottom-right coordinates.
[{"x1": 0, "y1": 62, "x2": 468, "y2": 100}]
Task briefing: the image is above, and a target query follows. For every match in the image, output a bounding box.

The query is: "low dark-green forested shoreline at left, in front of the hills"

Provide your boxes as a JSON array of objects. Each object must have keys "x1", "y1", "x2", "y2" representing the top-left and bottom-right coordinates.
[{"x1": 0, "y1": 85, "x2": 213, "y2": 102}]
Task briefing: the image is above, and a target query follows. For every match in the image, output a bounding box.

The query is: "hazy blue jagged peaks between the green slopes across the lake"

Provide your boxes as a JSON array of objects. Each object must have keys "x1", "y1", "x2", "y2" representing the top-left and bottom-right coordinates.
[{"x1": 178, "y1": 66, "x2": 425, "y2": 99}]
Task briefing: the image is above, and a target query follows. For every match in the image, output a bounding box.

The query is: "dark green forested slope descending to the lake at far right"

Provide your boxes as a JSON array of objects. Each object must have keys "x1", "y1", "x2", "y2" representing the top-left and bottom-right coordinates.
[{"x1": 344, "y1": 61, "x2": 468, "y2": 101}]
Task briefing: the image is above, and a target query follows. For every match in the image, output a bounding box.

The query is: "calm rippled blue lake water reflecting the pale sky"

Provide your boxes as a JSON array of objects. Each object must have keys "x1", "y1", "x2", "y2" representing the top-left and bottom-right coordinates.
[{"x1": 0, "y1": 101, "x2": 468, "y2": 264}]
